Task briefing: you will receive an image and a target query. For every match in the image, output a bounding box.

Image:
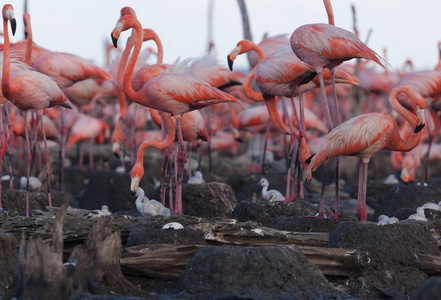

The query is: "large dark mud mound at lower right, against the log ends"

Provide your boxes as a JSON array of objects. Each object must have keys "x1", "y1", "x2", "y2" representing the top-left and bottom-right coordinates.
[{"x1": 328, "y1": 222, "x2": 440, "y2": 299}]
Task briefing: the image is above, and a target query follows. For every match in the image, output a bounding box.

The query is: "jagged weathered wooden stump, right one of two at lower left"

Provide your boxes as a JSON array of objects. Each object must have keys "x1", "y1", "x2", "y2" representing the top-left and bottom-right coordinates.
[{"x1": 69, "y1": 217, "x2": 144, "y2": 296}]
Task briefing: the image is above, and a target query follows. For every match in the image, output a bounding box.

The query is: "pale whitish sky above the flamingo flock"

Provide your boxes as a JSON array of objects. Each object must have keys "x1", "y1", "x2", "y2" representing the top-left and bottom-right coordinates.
[{"x1": 4, "y1": 0, "x2": 441, "y2": 70}]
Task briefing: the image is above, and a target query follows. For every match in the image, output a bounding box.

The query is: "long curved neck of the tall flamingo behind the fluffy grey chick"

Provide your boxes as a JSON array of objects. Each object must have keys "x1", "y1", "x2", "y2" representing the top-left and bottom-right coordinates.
[{"x1": 124, "y1": 18, "x2": 145, "y2": 102}]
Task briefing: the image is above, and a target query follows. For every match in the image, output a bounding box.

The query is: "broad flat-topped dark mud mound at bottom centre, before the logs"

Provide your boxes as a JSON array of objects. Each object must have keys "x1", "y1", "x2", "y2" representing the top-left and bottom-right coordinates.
[{"x1": 177, "y1": 246, "x2": 343, "y2": 299}]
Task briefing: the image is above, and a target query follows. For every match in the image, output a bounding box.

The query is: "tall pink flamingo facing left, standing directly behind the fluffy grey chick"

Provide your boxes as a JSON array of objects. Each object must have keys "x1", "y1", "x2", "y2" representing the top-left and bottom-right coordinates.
[{"x1": 111, "y1": 15, "x2": 240, "y2": 213}]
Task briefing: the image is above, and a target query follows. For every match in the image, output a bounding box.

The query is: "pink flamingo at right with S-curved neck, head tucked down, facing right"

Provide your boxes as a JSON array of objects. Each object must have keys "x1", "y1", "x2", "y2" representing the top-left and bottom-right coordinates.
[{"x1": 304, "y1": 86, "x2": 426, "y2": 222}]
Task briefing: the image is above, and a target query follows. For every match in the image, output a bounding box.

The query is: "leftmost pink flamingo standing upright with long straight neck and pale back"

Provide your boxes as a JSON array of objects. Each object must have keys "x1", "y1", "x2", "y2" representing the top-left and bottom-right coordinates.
[{"x1": 2, "y1": 4, "x2": 71, "y2": 216}]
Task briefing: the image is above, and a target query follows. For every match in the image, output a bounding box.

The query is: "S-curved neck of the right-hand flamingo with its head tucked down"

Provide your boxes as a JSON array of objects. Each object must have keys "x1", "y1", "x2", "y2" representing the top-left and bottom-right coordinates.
[{"x1": 387, "y1": 86, "x2": 424, "y2": 151}]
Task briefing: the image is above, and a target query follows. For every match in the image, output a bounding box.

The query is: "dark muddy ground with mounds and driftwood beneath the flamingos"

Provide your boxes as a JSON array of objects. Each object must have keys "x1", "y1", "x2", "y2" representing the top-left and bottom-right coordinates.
[{"x1": 0, "y1": 146, "x2": 441, "y2": 299}]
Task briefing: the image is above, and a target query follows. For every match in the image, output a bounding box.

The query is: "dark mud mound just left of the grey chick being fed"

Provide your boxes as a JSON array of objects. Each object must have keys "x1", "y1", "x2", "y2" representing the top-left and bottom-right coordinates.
[{"x1": 78, "y1": 171, "x2": 154, "y2": 212}]
